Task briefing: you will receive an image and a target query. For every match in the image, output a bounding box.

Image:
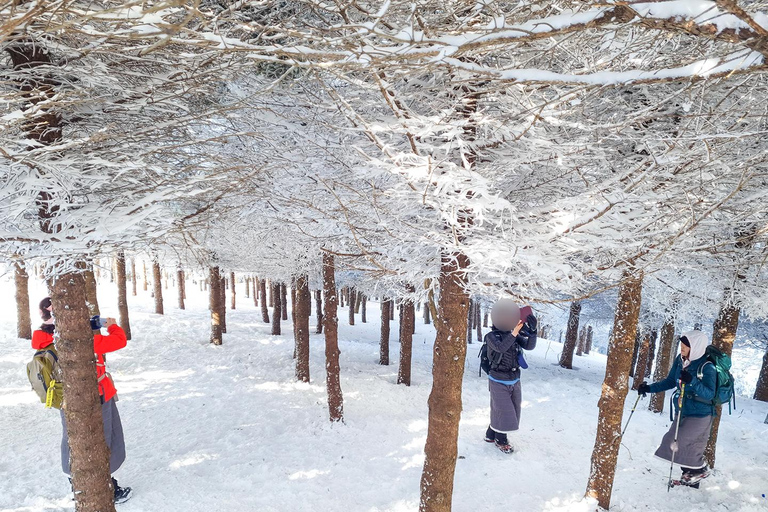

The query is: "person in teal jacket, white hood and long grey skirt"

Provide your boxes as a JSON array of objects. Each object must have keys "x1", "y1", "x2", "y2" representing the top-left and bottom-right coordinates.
[{"x1": 637, "y1": 331, "x2": 717, "y2": 488}]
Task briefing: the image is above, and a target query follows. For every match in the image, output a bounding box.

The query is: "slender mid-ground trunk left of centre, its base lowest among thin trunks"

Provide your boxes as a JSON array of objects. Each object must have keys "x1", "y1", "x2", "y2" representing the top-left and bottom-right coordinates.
[{"x1": 318, "y1": 253, "x2": 344, "y2": 422}]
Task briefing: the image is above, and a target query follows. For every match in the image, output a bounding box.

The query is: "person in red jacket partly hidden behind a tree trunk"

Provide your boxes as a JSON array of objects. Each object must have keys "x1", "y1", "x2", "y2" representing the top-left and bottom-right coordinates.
[{"x1": 32, "y1": 297, "x2": 131, "y2": 503}]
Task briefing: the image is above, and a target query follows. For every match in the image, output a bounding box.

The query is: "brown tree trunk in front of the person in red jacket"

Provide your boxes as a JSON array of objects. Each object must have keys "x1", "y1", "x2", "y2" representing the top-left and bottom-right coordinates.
[{"x1": 49, "y1": 273, "x2": 115, "y2": 512}]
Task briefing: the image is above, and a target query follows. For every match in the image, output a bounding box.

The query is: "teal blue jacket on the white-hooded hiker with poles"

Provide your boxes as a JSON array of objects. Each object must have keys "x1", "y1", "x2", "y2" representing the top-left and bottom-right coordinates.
[{"x1": 649, "y1": 354, "x2": 717, "y2": 417}]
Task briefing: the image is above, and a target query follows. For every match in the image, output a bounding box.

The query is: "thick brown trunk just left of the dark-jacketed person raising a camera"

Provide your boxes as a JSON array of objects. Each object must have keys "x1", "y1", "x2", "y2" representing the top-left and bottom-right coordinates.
[{"x1": 419, "y1": 253, "x2": 469, "y2": 512}]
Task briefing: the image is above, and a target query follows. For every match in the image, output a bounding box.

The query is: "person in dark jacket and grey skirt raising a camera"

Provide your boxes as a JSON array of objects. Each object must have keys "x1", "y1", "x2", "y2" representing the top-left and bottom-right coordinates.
[{"x1": 485, "y1": 299, "x2": 537, "y2": 453}]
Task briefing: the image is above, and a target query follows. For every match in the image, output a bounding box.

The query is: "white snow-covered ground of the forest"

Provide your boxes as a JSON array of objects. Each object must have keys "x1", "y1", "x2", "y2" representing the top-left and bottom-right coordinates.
[{"x1": 0, "y1": 276, "x2": 768, "y2": 512}]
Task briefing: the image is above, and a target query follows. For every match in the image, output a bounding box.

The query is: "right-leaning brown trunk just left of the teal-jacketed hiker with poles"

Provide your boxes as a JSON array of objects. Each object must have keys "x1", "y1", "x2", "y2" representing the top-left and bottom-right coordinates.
[{"x1": 586, "y1": 270, "x2": 643, "y2": 510}]
